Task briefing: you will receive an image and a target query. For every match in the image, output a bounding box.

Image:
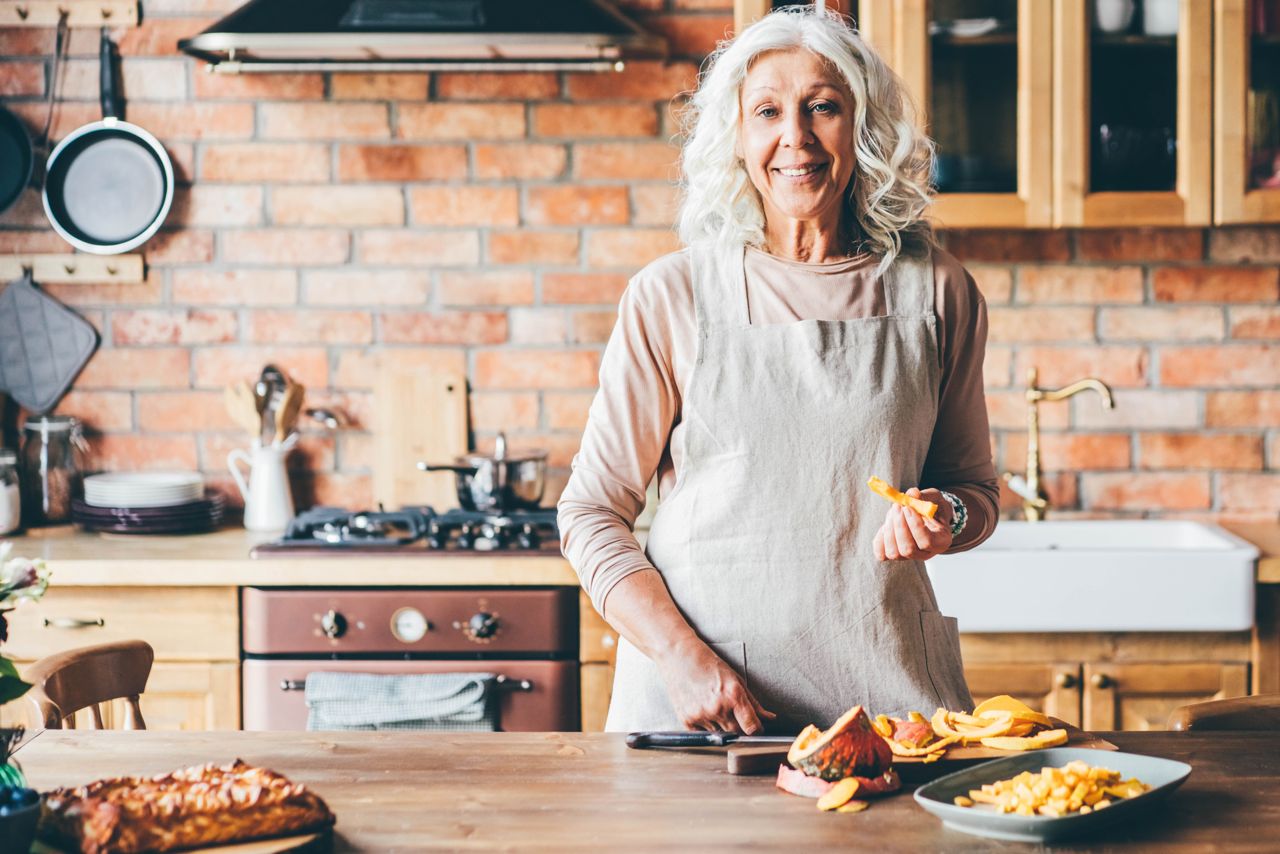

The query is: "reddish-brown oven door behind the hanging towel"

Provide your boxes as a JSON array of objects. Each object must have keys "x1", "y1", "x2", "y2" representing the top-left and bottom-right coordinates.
[{"x1": 242, "y1": 658, "x2": 579, "y2": 732}]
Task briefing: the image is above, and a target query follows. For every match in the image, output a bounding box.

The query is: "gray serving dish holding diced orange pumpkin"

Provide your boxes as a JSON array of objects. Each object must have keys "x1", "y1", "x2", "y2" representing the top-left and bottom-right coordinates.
[{"x1": 915, "y1": 748, "x2": 1192, "y2": 842}]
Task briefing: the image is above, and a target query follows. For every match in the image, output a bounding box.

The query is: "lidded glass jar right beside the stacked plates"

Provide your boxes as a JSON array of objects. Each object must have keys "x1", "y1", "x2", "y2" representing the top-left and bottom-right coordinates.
[{"x1": 20, "y1": 415, "x2": 84, "y2": 528}]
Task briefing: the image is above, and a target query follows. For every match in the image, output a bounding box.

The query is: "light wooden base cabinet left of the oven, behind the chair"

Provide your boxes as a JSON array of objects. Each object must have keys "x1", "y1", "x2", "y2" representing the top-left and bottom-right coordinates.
[{"x1": 0, "y1": 586, "x2": 241, "y2": 730}]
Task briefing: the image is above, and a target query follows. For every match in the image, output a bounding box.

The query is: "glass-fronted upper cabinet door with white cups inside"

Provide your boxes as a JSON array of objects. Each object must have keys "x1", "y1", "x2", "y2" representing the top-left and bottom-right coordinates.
[{"x1": 1053, "y1": 0, "x2": 1213, "y2": 225}]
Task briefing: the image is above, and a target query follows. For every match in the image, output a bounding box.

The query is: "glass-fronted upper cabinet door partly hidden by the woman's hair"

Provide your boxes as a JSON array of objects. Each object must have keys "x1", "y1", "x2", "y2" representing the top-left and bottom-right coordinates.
[{"x1": 892, "y1": 0, "x2": 1053, "y2": 228}]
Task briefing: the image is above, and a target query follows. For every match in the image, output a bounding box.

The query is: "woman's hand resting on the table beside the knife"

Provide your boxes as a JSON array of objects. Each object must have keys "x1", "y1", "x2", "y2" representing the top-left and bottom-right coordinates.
[{"x1": 658, "y1": 638, "x2": 777, "y2": 735}]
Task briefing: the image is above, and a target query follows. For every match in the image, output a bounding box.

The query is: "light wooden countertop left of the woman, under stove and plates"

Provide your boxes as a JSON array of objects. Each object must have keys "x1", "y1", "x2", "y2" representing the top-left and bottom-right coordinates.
[{"x1": 0, "y1": 526, "x2": 579, "y2": 586}]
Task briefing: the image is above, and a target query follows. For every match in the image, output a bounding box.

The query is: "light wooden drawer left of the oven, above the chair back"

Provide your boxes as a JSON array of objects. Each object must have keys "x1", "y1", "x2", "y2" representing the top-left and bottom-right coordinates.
[{"x1": 4, "y1": 588, "x2": 239, "y2": 661}]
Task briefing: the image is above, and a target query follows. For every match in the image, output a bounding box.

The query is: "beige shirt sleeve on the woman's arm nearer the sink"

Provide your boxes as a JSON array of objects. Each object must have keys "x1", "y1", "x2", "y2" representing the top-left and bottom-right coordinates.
[{"x1": 920, "y1": 252, "x2": 1000, "y2": 552}]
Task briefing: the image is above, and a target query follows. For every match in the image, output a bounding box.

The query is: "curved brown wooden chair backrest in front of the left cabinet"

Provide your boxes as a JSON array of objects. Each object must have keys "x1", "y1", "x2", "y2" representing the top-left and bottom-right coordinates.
[{"x1": 22, "y1": 640, "x2": 155, "y2": 730}]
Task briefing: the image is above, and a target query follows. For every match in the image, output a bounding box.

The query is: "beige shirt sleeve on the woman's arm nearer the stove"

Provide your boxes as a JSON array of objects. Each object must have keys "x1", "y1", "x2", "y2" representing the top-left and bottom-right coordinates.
[{"x1": 557, "y1": 267, "x2": 680, "y2": 615}]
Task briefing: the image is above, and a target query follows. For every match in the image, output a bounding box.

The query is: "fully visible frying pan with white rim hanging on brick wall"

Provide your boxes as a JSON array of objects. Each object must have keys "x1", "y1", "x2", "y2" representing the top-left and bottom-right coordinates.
[{"x1": 44, "y1": 29, "x2": 173, "y2": 255}]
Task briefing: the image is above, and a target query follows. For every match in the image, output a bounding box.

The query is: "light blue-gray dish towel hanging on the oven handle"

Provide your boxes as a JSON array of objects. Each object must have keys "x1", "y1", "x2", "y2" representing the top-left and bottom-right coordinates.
[{"x1": 306, "y1": 672, "x2": 498, "y2": 732}]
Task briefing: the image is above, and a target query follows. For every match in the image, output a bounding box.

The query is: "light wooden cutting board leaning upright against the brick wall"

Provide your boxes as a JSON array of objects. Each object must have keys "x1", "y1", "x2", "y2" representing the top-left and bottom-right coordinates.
[{"x1": 374, "y1": 352, "x2": 467, "y2": 511}]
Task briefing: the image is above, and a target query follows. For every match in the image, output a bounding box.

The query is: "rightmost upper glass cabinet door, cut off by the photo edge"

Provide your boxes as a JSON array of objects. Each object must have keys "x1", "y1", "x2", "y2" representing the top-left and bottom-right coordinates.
[{"x1": 1213, "y1": 0, "x2": 1280, "y2": 224}]
